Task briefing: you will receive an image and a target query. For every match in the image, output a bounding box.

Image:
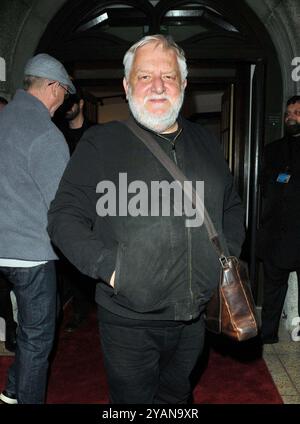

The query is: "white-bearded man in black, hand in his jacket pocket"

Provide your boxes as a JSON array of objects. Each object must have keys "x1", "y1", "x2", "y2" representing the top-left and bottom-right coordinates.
[{"x1": 48, "y1": 35, "x2": 244, "y2": 404}]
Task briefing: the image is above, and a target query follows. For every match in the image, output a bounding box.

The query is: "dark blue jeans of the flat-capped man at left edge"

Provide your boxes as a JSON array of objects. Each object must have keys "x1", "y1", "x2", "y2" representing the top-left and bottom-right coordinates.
[{"x1": 1, "y1": 261, "x2": 56, "y2": 404}]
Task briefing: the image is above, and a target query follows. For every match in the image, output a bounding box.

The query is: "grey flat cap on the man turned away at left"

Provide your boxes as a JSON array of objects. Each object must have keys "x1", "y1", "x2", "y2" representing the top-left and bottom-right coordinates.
[{"x1": 24, "y1": 53, "x2": 76, "y2": 94}]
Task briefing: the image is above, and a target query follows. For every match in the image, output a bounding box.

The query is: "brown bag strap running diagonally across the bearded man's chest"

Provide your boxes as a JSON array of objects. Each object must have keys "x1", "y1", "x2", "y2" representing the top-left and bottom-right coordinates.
[{"x1": 123, "y1": 117, "x2": 227, "y2": 260}]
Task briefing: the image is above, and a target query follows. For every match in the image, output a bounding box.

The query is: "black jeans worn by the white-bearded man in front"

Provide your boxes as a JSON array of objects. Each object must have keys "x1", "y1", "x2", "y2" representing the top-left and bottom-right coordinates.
[{"x1": 99, "y1": 308, "x2": 205, "y2": 404}]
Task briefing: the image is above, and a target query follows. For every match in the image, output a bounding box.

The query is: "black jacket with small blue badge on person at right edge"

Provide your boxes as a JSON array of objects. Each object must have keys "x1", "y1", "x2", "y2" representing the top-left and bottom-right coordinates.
[{"x1": 257, "y1": 137, "x2": 300, "y2": 269}]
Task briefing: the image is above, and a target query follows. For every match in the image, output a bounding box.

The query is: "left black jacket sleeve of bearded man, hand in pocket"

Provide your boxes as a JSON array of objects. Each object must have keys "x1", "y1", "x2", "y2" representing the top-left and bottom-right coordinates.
[{"x1": 48, "y1": 130, "x2": 117, "y2": 282}]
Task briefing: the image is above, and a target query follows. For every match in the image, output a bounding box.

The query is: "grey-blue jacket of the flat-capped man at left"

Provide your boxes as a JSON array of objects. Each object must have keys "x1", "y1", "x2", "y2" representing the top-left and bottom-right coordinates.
[{"x1": 0, "y1": 90, "x2": 69, "y2": 261}]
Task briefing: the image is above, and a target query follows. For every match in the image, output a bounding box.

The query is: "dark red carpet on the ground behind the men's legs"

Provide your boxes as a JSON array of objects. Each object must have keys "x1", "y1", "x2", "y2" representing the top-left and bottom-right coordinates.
[{"x1": 0, "y1": 314, "x2": 282, "y2": 404}]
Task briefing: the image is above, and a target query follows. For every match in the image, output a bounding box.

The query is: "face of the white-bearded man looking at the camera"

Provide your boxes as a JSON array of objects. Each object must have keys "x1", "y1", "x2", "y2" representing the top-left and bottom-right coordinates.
[{"x1": 123, "y1": 42, "x2": 186, "y2": 133}]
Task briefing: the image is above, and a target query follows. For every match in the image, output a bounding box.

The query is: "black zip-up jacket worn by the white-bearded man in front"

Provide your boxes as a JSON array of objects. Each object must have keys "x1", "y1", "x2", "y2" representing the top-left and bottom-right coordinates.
[{"x1": 48, "y1": 119, "x2": 244, "y2": 320}]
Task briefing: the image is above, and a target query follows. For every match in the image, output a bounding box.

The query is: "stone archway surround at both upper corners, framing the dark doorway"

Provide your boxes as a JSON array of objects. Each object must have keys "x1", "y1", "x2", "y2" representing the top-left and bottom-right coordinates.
[{"x1": 0, "y1": 0, "x2": 300, "y2": 99}]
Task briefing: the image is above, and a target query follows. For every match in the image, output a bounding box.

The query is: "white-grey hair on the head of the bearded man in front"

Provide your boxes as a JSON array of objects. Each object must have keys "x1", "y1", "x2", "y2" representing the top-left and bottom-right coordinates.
[{"x1": 123, "y1": 34, "x2": 188, "y2": 81}]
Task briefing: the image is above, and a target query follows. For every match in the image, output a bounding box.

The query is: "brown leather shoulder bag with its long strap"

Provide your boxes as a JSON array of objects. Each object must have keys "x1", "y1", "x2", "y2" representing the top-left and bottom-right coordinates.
[{"x1": 124, "y1": 118, "x2": 258, "y2": 341}]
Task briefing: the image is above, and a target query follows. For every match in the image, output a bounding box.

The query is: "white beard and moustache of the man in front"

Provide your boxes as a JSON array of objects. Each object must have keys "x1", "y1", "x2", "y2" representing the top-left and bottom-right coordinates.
[{"x1": 127, "y1": 87, "x2": 184, "y2": 133}]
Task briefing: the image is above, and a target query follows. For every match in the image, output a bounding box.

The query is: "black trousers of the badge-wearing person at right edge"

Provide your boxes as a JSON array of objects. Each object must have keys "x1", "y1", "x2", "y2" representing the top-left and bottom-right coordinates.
[{"x1": 261, "y1": 260, "x2": 300, "y2": 339}]
